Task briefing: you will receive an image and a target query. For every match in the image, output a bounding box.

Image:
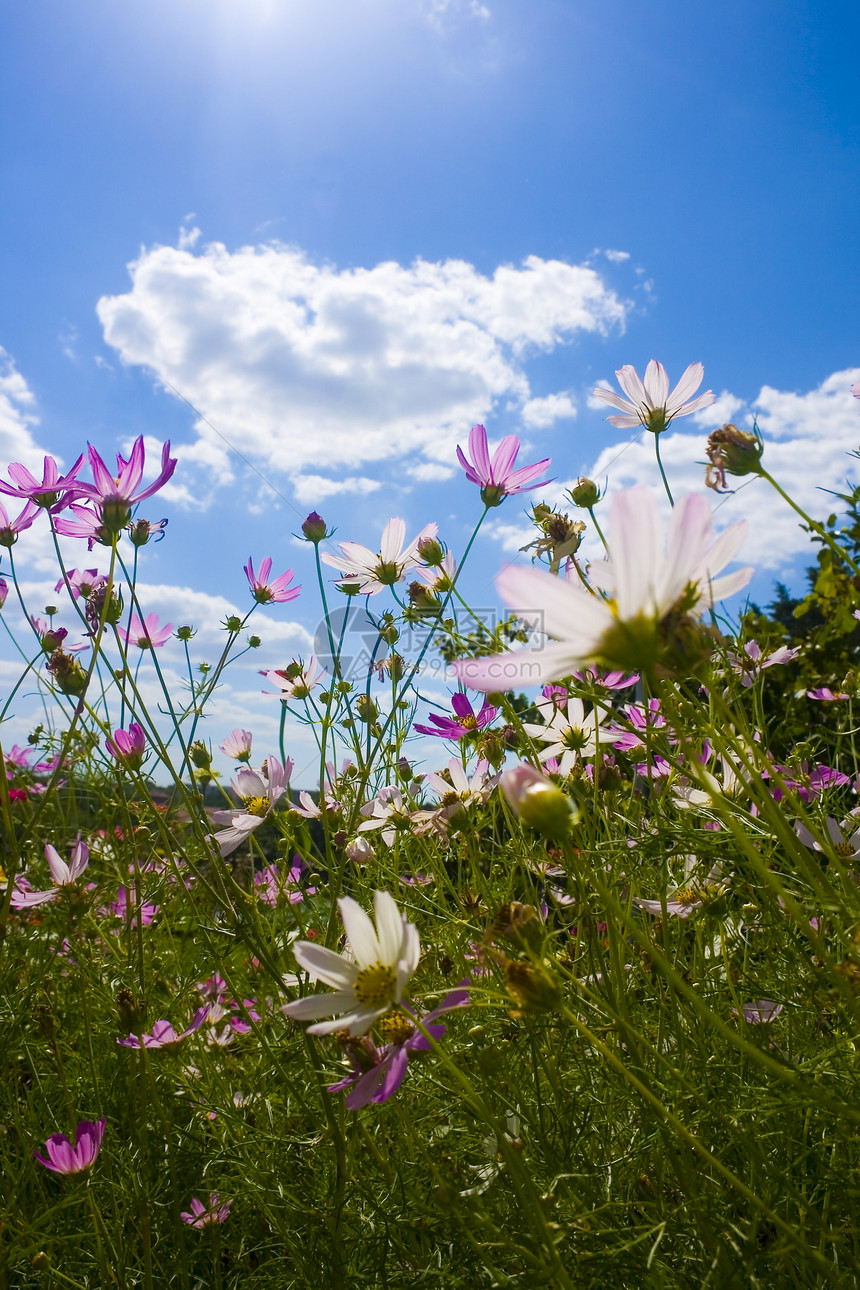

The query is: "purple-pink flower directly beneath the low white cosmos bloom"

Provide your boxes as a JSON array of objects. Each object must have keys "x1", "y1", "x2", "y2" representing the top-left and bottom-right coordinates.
[{"x1": 329, "y1": 988, "x2": 469, "y2": 1111}]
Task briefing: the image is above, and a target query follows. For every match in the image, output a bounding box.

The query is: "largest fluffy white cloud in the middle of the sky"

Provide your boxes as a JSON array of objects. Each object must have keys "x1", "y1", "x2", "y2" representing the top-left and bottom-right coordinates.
[{"x1": 98, "y1": 243, "x2": 629, "y2": 490}]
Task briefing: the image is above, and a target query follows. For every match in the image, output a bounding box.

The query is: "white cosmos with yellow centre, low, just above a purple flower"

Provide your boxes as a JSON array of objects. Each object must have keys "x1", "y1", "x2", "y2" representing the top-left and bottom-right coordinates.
[{"x1": 281, "y1": 891, "x2": 420, "y2": 1036}]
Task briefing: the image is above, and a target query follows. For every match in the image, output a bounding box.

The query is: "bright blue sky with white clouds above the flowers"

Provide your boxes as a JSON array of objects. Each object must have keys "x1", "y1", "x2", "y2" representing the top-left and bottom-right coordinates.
[{"x1": 0, "y1": 0, "x2": 860, "y2": 774}]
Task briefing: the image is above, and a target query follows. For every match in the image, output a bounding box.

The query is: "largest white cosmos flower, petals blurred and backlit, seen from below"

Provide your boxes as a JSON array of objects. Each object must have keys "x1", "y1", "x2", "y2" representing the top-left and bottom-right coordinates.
[{"x1": 453, "y1": 484, "x2": 753, "y2": 691}]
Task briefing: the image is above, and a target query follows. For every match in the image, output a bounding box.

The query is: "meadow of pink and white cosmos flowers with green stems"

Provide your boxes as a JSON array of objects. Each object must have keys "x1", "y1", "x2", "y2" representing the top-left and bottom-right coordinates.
[{"x1": 0, "y1": 362, "x2": 860, "y2": 1290}]
